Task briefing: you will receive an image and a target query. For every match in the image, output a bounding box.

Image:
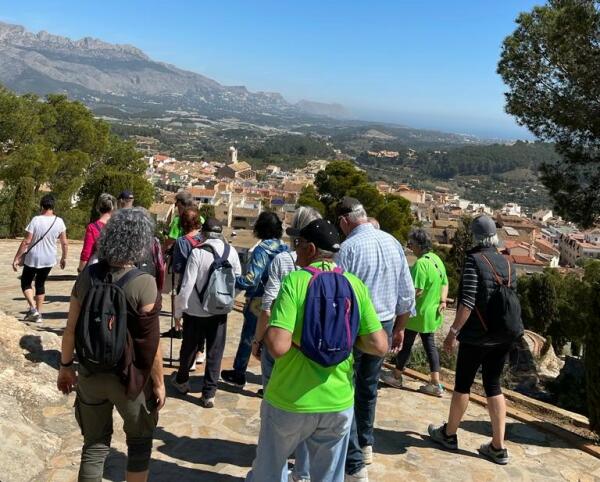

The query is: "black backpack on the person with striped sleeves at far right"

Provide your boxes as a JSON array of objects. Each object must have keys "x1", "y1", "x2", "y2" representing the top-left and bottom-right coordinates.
[{"x1": 475, "y1": 254, "x2": 524, "y2": 340}]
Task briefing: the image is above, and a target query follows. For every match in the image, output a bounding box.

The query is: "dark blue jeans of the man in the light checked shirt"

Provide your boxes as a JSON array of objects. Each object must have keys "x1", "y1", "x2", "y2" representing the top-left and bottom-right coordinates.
[{"x1": 346, "y1": 320, "x2": 394, "y2": 475}]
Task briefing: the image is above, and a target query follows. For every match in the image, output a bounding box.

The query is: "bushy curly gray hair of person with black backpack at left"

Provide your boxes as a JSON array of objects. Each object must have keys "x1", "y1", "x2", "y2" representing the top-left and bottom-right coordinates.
[{"x1": 98, "y1": 207, "x2": 155, "y2": 265}]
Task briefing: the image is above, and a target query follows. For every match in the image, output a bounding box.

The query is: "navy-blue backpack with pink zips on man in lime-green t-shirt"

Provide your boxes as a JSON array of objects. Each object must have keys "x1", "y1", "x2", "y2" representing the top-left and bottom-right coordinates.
[{"x1": 297, "y1": 266, "x2": 359, "y2": 367}]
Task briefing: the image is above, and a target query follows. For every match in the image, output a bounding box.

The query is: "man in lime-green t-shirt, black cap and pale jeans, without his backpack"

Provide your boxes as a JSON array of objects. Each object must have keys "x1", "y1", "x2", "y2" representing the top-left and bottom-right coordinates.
[{"x1": 246, "y1": 219, "x2": 388, "y2": 482}]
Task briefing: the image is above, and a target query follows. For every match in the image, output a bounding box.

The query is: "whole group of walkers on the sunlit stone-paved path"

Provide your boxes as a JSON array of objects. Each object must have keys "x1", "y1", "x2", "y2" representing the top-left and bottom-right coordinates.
[{"x1": 13, "y1": 191, "x2": 522, "y2": 482}]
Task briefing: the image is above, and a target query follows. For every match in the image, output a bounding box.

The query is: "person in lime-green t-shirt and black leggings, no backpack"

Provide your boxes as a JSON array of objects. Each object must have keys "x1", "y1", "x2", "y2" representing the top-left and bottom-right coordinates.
[{"x1": 381, "y1": 229, "x2": 448, "y2": 397}]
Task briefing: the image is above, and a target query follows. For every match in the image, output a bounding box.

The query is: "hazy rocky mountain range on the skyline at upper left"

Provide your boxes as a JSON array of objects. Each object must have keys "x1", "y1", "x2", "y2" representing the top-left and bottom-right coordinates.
[{"x1": 0, "y1": 22, "x2": 351, "y2": 120}]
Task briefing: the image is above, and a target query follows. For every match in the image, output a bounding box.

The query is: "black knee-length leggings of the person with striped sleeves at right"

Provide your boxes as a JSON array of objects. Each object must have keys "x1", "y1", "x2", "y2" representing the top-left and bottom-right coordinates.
[{"x1": 454, "y1": 343, "x2": 511, "y2": 397}]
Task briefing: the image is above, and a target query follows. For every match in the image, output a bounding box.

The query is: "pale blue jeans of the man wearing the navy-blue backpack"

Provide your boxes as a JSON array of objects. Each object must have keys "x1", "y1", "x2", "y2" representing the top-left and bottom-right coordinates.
[{"x1": 246, "y1": 401, "x2": 353, "y2": 482}]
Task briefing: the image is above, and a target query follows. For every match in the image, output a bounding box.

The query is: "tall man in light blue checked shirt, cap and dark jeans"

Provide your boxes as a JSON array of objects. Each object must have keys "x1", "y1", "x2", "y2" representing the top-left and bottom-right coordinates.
[{"x1": 336, "y1": 197, "x2": 415, "y2": 482}]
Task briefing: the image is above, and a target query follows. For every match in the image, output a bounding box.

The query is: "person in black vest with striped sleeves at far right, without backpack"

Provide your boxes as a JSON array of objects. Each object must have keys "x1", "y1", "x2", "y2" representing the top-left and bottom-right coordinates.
[{"x1": 428, "y1": 216, "x2": 517, "y2": 465}]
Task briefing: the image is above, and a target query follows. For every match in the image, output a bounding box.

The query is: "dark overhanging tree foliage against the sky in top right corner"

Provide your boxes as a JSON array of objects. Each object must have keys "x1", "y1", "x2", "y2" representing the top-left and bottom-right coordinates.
[{"x1": 498, "y1": 0, "x2": 600, "y2": 226}]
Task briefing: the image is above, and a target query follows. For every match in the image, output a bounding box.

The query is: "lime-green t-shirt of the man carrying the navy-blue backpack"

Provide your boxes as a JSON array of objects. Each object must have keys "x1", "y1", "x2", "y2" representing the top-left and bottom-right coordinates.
[{"x1": 265, "y1": 262, "x2": 381, "y2": 413}]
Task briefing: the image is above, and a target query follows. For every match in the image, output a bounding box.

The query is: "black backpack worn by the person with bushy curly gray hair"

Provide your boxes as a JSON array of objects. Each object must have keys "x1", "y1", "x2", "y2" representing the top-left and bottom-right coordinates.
[{"x1": 75, "y1": 262, "x2": 143, "y2": 373}]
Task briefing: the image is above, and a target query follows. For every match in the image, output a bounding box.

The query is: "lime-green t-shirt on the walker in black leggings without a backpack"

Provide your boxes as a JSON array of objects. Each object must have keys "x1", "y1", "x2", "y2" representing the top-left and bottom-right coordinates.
[{"x1": 406, "y1": 252, "x2": 448, "y2": 333}]
